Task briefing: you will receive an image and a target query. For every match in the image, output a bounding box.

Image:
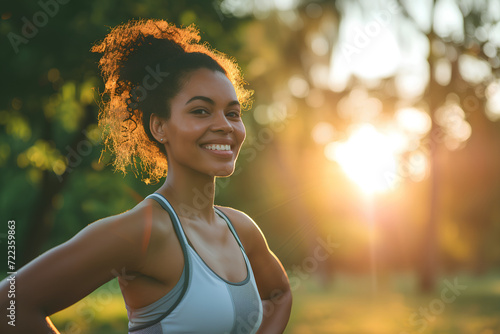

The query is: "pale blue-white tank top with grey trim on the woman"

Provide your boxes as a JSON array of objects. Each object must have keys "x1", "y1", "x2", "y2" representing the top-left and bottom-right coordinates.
[{"x1": 126, "y1": 193, "x2": 262, "y2": 334}]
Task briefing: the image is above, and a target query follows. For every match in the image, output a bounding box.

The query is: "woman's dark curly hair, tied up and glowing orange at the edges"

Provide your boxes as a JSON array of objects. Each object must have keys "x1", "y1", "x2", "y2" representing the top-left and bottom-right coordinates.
[{"x1": 91, "y1": 19, "x2": 253, "y2": 184}]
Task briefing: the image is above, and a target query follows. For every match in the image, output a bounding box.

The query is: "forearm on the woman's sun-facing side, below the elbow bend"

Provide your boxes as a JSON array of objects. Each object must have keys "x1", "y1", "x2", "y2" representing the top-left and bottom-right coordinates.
[{"x1": 257, "y1": 290, "x2": 292, "y2": 334}]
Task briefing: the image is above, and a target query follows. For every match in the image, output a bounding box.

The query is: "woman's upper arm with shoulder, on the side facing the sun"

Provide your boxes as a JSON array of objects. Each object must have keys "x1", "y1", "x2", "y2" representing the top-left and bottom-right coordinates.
[{"x1": 221, "y1": 208, "x2": 290, "y2": 299}]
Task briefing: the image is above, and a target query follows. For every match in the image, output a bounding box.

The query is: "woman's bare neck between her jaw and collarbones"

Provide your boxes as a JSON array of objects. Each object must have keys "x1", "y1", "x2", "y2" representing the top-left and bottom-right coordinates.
[{"x1": 157, "y1": 170, "x2": 215, "y2": 223}]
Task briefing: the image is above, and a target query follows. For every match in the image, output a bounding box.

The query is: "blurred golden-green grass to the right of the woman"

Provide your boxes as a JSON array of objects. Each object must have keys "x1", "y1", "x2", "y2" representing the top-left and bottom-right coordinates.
[{"x1": 287, "y1": 275, "x2": 500, "y2": 334}]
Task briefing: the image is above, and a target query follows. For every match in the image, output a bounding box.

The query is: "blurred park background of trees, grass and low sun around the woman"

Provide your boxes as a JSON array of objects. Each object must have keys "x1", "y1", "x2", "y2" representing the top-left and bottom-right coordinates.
[{"x1": 0, "y1": 0, "x2": 500, "y2": 334}]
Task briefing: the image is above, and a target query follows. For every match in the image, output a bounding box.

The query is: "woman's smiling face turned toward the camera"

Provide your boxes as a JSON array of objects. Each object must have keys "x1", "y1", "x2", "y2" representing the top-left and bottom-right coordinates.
[{"x1": 165, "y1": 68, "x2": 245, "y2": 176}]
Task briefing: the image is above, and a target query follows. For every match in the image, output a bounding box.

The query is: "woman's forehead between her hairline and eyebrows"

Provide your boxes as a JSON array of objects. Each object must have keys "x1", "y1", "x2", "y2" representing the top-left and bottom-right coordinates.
[{"x1": 174, "y1": 68, "x2": 238, "y2": 103}]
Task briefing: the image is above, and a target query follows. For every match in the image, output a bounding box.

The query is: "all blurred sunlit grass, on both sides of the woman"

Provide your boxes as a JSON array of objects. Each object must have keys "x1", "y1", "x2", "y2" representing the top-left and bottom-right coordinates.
[{"x1": 51, "y1": 273, "x2": 500, "y2": 334}]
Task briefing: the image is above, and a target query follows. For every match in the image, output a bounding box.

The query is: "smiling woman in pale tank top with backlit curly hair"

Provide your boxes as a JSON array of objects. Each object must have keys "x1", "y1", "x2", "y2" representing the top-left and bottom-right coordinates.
[{"x1": 0, "y1": 20, "x2": 292, "y2": 334}]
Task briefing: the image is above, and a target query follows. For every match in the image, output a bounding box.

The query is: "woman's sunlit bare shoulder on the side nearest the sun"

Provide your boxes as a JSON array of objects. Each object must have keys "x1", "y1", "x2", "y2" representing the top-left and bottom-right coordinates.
[{"x1": 217, "y1": 206, "x2": 267, "y2": 254}]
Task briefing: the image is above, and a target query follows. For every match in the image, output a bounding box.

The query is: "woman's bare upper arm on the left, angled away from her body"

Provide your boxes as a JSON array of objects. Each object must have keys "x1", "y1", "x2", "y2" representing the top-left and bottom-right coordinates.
[{"x1": 0, "y1": 207, "x2": 150, "y2": 315}]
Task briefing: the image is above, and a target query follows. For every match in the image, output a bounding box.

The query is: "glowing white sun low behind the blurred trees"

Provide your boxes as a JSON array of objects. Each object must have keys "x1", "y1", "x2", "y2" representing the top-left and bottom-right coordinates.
[{"x1": 325, "y1": 124, "x2": 405, "y2": 194}]
